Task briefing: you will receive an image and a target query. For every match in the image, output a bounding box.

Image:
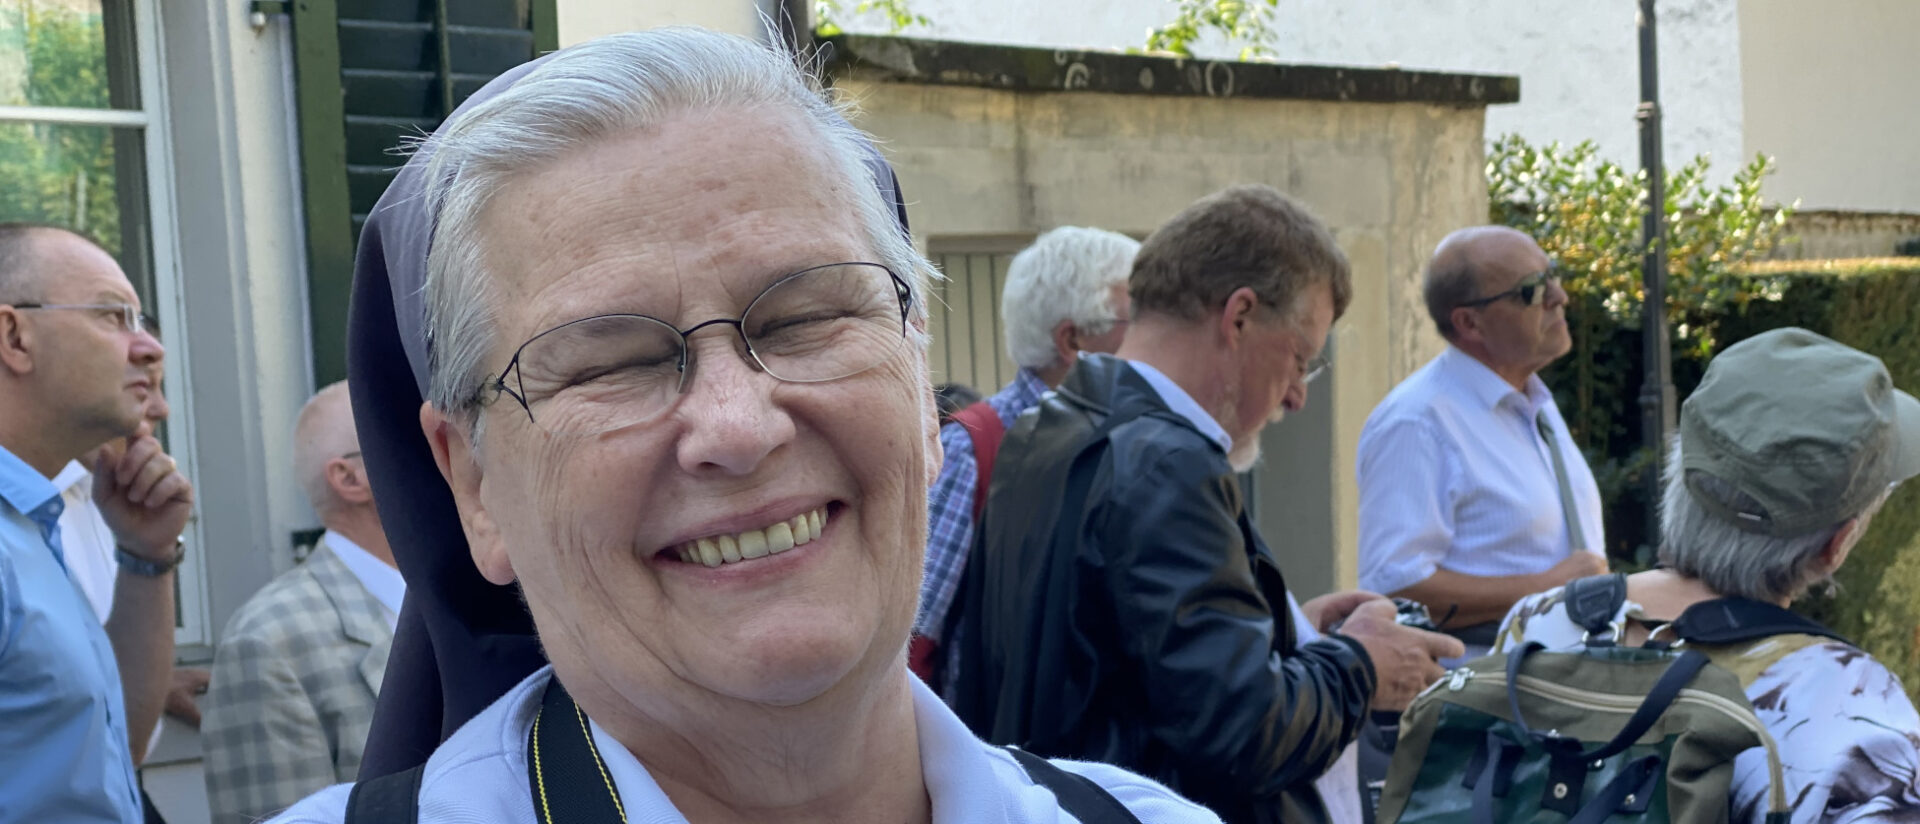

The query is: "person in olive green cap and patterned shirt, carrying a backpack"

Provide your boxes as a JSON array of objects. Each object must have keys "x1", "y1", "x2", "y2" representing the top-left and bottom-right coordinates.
[{"x1": 1500, "y1": 328, "x2": 1920, "y2": 824}]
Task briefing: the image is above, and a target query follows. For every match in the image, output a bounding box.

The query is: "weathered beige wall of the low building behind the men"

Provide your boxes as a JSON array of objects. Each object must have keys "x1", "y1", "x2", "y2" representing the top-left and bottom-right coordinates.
[{"x1": 835, "y1": 40, "x2": 1498, "y2": 597}]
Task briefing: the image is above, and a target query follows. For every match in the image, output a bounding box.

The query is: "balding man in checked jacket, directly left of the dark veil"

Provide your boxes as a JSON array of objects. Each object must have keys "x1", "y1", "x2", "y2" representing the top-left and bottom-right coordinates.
[{"x1": 202, "y1": 380, "x2": 407, "y2": 824}]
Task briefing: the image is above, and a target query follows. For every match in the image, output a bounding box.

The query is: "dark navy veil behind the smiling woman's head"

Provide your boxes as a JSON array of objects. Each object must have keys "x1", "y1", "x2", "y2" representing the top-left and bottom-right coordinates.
[{"x1": 348, "y1": 58, "x2": 906, "y2": 780}]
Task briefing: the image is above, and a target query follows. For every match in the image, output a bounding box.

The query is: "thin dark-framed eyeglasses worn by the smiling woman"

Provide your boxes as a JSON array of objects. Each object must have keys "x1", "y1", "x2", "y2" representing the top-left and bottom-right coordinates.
[{"x1": 474, "y1": 263, "x2": 914, "y2": 434}]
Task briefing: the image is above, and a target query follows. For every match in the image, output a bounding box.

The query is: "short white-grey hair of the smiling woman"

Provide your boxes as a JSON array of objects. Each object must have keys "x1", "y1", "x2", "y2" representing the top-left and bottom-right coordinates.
[{"x1": 422, "y1": 27, "x2": 937, "y2": 430}]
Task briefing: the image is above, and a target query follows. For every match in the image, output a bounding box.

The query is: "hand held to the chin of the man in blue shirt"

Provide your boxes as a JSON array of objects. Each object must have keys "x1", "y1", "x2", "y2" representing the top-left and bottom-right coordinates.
[{"x1": 94, "y1": 430, "x2": 194, "y2": 563}]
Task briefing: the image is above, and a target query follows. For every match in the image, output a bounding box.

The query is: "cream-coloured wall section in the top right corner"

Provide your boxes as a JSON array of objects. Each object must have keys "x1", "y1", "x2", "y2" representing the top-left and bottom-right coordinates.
[{"x1": 1740, "y1": 0, "x2": 1920, "y2": 212}]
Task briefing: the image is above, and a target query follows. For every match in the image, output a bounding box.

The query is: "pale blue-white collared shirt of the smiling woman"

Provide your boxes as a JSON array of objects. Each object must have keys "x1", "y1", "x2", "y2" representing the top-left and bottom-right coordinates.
[{"x1": 273, "y1": 666, "x2": 1219, "y2": 824}]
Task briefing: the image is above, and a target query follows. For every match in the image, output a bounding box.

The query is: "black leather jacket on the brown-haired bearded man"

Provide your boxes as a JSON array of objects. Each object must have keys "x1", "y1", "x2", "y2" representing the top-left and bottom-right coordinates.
[{"x1": 948, "y1": 355, "x2": 1375, "y2": 824}]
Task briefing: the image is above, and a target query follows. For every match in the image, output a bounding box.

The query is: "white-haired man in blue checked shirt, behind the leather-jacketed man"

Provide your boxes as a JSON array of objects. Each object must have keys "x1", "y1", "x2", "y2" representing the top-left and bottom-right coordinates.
[{"x1": 912, "y1": 227, "x2": 1140, "y2": 682}]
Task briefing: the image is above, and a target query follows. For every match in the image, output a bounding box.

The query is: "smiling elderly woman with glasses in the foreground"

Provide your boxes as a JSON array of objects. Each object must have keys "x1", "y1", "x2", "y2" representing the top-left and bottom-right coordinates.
[{"x1": 280, "y1": 29, "x2": 1217, "y2": 822}]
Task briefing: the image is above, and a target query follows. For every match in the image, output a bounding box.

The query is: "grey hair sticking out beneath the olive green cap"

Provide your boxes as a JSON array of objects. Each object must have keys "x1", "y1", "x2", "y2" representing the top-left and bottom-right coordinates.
[{"x1": 1661, "y1": 436, "x2": 1893, "y2": 603}]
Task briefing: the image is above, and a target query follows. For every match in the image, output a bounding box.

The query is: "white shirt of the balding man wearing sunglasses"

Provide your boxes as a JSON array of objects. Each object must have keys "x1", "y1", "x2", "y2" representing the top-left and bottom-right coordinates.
[{"x1": 1357, "y1": 346, "x2": 1605, "y2": 594}]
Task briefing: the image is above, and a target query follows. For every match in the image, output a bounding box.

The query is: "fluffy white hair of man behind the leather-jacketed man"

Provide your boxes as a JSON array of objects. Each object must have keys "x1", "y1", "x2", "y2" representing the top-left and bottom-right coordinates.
[{"x1": 1000, "y1": 227, "x2": 1140, "y2": 369}]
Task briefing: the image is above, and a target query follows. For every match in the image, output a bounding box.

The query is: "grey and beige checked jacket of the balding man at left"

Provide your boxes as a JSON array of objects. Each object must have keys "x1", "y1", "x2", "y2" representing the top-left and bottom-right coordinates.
[{"x1": 200, "y1": 542, "x2": 394, "y2": 824}]
